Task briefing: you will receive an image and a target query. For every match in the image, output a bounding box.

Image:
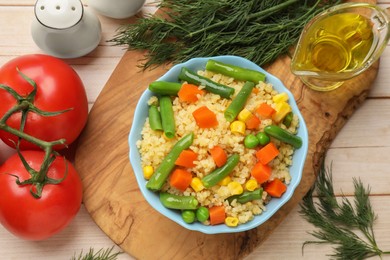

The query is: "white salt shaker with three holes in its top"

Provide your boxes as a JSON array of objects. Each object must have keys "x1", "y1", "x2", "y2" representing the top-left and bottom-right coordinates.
[{"x1": 31, "y1": 0, "x2": 102, "y2": 59}]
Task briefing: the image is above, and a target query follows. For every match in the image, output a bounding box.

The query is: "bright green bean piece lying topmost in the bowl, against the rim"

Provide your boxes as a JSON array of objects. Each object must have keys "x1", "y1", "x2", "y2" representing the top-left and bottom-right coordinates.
[{"x1": 206, "y1": 60, "x2": 266, "y2": 84}]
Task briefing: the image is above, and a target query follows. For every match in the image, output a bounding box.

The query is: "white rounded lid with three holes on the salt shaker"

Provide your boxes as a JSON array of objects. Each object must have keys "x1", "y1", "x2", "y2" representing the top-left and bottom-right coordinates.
[{"x1": 34, "y1": 0, "x2": 84, "y2": 29}]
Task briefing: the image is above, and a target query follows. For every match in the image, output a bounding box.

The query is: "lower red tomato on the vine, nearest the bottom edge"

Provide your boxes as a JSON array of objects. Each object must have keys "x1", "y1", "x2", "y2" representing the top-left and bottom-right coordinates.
[{"x1": 0, "y1": 151, "x2": 82, "y2": 240}]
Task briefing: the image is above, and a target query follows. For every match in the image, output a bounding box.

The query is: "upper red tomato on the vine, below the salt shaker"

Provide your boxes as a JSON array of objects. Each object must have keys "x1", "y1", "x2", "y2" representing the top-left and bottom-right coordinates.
[{"x1": 0, "y1": 54, "x2": 88, "y2": 150}]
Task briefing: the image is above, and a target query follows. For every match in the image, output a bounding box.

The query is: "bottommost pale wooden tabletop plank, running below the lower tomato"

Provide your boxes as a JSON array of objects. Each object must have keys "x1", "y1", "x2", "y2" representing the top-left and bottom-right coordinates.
[{"x1": 0, "y1": 196, "x2": 390, "y2": 260}]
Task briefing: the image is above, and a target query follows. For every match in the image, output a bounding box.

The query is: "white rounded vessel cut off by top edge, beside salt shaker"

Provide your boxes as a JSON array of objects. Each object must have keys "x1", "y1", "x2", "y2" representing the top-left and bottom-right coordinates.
[{"x1": 88, "y1": 0, "x2": 146, "y2": 19}]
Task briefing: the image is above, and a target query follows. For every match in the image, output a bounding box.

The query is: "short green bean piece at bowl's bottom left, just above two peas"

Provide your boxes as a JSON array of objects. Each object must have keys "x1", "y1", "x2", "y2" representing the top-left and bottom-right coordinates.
[{"x1": 160, "y1": 192, "x2": 199, "y2": 210}]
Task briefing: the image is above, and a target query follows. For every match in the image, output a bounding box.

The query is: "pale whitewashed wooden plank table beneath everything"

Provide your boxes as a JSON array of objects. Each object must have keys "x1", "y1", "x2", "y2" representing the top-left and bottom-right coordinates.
[{"x1": 0, "y1": 0, "x2": 390, "y2": 260}]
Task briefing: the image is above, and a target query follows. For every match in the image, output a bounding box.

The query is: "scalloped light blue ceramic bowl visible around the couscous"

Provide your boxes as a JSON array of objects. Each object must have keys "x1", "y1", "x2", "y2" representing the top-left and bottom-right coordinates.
[{"x1": 129, "y1": 56, "x2": 309, "y2": 234}]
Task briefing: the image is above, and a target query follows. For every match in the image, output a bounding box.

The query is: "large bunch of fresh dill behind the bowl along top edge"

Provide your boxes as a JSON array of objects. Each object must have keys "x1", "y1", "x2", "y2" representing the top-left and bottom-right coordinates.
[{"x1": 110, "y1": 0, "x2": 342, "y2": 68}]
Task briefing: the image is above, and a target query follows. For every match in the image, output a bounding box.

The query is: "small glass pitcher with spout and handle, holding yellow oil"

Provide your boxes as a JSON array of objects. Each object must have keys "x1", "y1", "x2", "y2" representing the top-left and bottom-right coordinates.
[{"x1": 291, "y1": 3, "x2": 390, "y2": 91}]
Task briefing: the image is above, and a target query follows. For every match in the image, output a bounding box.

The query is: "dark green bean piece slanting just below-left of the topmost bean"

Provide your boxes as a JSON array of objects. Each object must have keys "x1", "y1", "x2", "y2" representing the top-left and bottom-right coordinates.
[{"x1": 179, "y1": 67, "x2": 234, "y2": 98}]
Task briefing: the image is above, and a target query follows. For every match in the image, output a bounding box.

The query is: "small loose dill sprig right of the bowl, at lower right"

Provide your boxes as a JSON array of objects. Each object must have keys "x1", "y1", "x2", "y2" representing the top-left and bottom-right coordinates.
[{"x1": 300, "y1": 165, "x2": 390, "y2": 259}]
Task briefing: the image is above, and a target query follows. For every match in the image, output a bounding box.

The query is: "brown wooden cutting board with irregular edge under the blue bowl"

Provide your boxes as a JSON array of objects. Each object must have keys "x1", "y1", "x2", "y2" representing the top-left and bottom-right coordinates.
[{"x1": 75, "y1": 1, "x2": 379, "y2": 259}]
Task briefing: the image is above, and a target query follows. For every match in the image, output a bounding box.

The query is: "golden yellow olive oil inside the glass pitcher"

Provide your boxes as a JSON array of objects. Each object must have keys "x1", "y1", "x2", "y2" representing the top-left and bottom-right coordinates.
[{"x1": 292, "y1": 13, "x2": 374, "y2": 74}]
